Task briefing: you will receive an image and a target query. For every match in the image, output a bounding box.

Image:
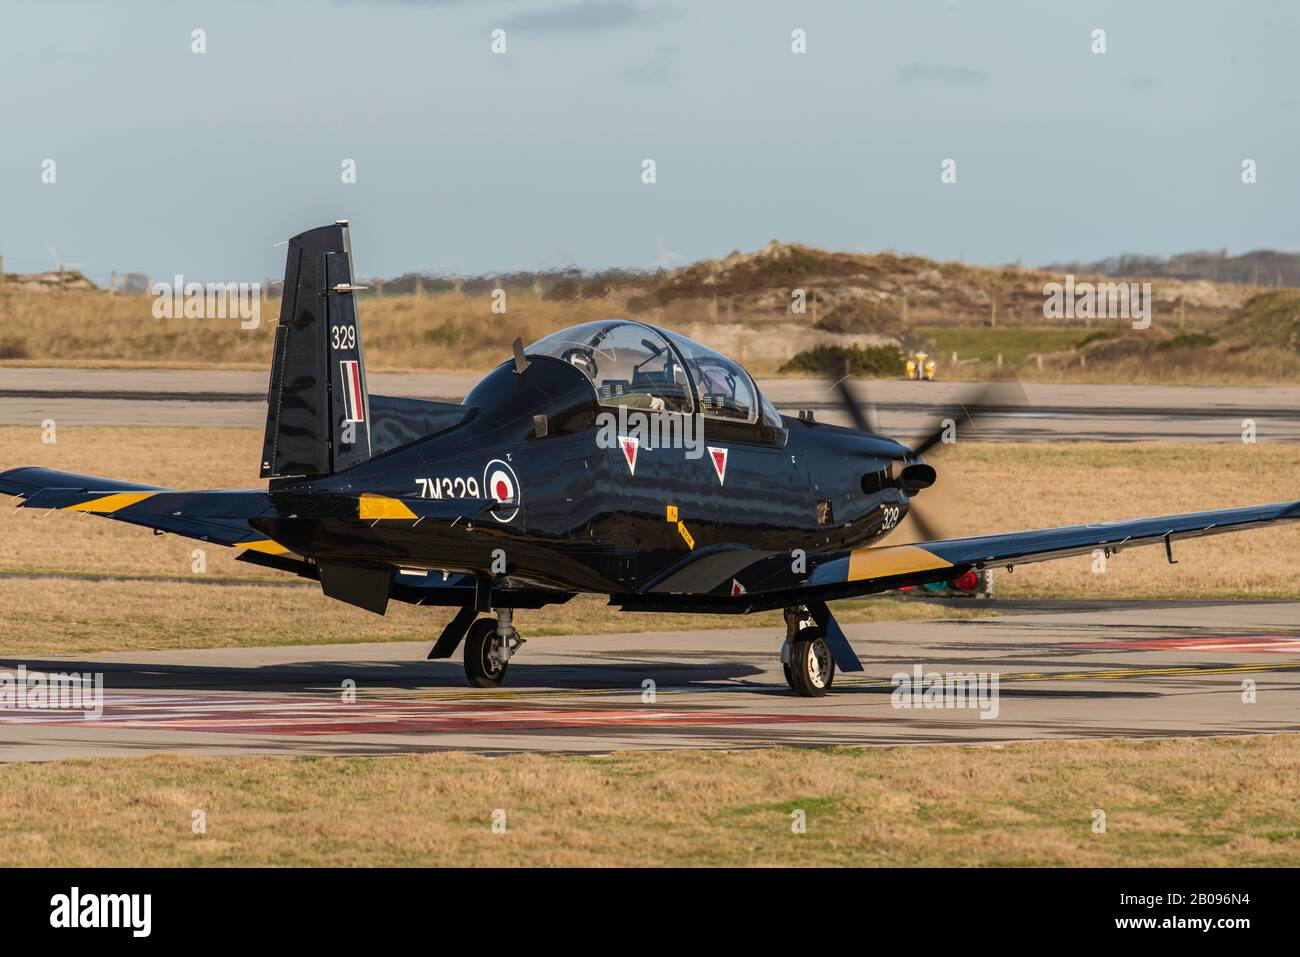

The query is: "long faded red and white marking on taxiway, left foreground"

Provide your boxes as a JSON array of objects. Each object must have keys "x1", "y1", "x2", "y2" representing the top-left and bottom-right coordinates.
[{"x1": 0, "y1": 692, "x2": 884, "y2": 735}]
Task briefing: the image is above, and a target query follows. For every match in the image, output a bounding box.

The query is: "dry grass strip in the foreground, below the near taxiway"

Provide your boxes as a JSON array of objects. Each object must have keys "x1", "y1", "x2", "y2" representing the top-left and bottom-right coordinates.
[{"x1": 0, "y1": 735, "x2": 1300, "y2": 866}]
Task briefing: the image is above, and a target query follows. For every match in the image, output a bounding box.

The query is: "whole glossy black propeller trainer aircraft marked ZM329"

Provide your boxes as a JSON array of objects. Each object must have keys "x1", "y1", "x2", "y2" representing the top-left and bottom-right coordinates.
[{"x1": 0, "y1": 221, "x2": 1300, "y2": 696}]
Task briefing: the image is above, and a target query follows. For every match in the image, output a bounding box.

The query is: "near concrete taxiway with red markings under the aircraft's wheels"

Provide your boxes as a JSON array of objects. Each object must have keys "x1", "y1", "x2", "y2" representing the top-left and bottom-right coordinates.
[{"x1": 0, "y1": 602, "x2": 1300, "y2": 761}]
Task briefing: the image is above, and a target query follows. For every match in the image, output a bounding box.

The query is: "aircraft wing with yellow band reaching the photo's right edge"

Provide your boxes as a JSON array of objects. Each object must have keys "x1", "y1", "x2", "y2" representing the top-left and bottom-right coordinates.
[{"x1": 611, "y1": 502, "x2": 1300, "y2": 614}]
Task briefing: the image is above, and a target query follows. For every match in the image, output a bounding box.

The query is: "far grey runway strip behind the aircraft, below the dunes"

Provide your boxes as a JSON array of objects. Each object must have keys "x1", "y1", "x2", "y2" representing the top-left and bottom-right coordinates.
[{"x1": 0, "y1": 368, "x2": 1300, "y2": 442}]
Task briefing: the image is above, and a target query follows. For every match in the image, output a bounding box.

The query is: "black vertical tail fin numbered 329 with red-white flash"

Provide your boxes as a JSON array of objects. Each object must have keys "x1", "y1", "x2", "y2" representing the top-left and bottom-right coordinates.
[{"x1": 261, "y1": 220, "x2": 371, "y2": 479}]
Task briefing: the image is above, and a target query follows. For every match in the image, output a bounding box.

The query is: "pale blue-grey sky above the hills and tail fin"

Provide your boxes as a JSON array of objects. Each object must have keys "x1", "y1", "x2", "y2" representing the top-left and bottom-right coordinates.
[{"x1": 0, "y1": 0, "x2": 1300, "y2": 281}]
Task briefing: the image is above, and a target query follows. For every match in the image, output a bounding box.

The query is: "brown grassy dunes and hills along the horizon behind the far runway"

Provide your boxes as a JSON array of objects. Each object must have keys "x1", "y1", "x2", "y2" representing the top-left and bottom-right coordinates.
[{"x1": 10, "y1": 241, "x2": 1300, "y2": 384}]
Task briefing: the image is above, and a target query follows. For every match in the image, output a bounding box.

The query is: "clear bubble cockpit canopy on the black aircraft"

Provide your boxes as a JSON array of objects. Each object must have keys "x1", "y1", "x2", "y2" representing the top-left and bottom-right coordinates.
[{"x1": 524, "y1": 319, "x2": 781, "y2": 429}]
